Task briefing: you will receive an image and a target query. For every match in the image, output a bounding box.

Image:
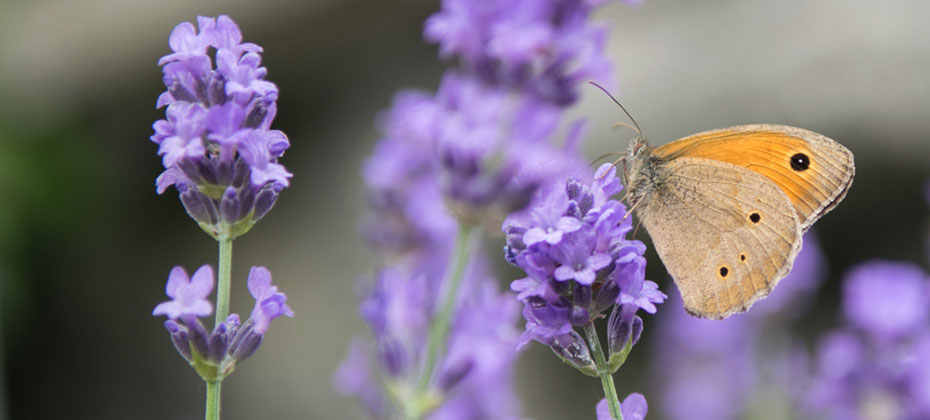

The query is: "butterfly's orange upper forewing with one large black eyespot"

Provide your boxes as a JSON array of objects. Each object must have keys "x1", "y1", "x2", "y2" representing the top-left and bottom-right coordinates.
[{"x1": 652, "y1": 124, "x2": 856, "y2": 231}]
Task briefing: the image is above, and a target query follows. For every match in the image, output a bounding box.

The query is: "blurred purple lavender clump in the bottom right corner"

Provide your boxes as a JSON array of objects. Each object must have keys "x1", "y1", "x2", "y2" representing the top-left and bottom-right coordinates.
[{"x1": 803, "y1": 261, "x2": 930, "y2": 420}]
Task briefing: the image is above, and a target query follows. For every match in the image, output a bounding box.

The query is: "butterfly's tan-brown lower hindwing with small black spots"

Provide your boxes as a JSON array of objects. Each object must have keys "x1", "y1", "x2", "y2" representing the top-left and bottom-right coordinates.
[{"x1": 637, "y1": 157, "x2": 802, "y2": 319}]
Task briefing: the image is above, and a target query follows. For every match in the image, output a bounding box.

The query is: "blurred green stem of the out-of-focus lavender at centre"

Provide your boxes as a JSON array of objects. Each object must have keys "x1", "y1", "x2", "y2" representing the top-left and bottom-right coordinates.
[{"x1": 414, "y1": 224, "x2": 472, "y2": 400}]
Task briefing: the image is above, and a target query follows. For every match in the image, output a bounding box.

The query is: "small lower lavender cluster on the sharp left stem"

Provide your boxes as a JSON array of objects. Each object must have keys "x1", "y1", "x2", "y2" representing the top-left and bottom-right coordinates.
[{"x1": 152, "y1": 265, "x2": 294, "y2": 381}]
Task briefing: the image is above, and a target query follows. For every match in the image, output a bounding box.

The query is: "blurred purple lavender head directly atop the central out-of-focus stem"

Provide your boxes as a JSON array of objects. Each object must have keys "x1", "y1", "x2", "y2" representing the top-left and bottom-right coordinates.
[{"x1": 434, "y1": 73, "x2": 585, "y2": 223}]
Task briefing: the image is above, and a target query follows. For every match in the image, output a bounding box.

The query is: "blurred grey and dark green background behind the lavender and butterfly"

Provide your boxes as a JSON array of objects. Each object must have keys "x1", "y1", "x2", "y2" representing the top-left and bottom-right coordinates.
[{"x1": 0, "y1": 0, "x2": 930, "y2": 420}]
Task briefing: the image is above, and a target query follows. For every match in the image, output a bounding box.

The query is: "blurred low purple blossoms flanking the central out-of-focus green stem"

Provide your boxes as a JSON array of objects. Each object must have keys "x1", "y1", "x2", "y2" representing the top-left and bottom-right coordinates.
[{"x1": 334, "y1": 264, "x2": 519, "y2": 420}]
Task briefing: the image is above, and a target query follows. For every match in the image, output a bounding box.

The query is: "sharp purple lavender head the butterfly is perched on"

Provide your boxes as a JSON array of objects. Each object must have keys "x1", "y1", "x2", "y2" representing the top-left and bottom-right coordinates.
[{"x1": 503, "y1": 164, "x2": 666, "y2": 364}]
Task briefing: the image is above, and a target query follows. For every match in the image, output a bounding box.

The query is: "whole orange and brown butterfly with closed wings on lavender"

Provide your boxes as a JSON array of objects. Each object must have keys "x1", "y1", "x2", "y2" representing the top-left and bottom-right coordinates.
[{"x1": 625, "y1": 125, "x2": 855, "y2": 319}]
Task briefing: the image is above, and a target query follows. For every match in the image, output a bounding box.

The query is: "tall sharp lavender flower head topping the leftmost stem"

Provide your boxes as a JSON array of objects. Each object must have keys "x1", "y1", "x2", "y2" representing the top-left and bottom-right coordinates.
[{"x1": 151, "y1": 15, "x2": 291, "y2": 238}]
